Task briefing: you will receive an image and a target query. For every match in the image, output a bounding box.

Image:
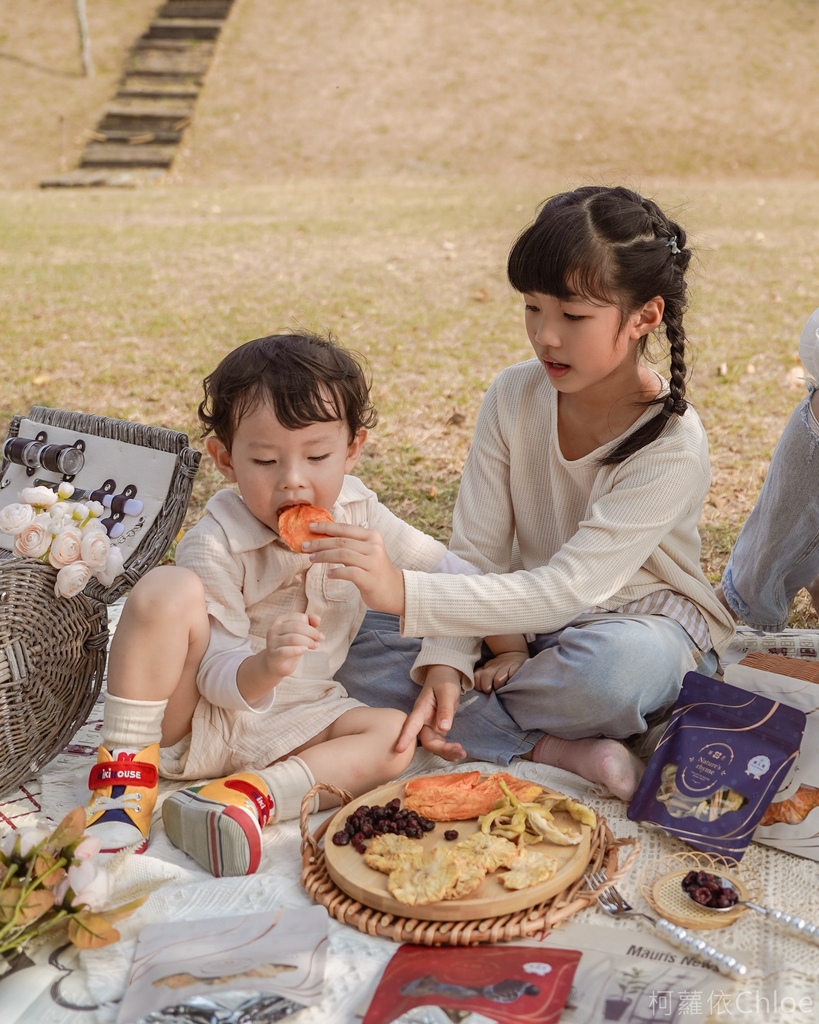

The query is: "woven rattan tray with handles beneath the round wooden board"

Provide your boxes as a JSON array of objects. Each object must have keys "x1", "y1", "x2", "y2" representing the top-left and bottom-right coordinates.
[{"x1": 300, "y1": 782, "x2": 640, "y2": 946}]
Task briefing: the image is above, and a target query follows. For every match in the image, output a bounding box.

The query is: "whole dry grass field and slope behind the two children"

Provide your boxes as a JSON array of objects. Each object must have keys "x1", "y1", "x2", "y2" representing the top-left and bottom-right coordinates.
[{"x1": 0, "y1": 0, "x2": 819, "y2": 624}]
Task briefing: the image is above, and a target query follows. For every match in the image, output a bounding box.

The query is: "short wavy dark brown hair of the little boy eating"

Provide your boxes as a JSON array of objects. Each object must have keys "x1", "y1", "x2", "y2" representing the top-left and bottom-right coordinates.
[{"x1": 199, "y1": 332, "x2": 378, "y2": 451}]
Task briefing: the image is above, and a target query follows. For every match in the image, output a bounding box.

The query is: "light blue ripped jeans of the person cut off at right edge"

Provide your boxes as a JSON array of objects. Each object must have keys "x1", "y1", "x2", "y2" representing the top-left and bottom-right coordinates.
[{"x1": 722, "y1": 384, "x2": 819, "y2": 633}]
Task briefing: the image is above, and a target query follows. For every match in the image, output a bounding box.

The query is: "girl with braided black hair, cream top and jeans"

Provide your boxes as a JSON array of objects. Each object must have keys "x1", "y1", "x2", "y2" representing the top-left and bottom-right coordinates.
[{"x1": 305, "y1": 186, "x2": 733, "y2": 800}]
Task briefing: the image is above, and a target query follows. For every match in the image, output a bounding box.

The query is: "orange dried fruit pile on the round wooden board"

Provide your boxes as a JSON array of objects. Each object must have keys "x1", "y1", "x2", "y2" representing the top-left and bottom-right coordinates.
[{"x1": 404, "y1": 771, "x2": 543, "y2": 821}]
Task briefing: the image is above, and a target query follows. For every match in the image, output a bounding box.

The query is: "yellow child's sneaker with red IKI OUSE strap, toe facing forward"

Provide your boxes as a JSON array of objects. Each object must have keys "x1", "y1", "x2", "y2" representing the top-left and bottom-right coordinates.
[{"x1": 86, "y1": 743, "x2": 160, "y2": 853}]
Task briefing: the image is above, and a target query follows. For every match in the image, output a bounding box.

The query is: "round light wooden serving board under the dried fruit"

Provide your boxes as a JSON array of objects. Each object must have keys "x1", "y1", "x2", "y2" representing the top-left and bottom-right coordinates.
[{"x1": 325, "y1": 782, "x2": 592, "y2": 921}]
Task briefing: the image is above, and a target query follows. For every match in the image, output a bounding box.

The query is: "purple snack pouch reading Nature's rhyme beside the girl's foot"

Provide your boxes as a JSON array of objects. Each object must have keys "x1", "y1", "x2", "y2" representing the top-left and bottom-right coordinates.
[{"x1": 627, "y1": 672, "x2": 807, "y2": 860}]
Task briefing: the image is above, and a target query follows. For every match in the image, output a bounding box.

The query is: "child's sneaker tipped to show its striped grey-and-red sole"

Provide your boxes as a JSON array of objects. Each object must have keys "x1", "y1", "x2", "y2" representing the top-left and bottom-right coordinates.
[{"x1": 162, "y1": 771, "x2": 275, "y2": 879}]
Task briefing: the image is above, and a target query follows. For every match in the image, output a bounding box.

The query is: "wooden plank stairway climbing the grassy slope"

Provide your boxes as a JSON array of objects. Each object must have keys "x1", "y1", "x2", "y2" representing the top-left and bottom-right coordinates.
[{"x1": 40, "y1": 0, "x2": 233, "y2": 188}]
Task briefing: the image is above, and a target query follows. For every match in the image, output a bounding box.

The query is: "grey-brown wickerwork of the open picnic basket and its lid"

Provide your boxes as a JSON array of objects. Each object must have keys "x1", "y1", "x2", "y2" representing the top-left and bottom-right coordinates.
[{"x1": 0, "y1": 407, "x2": 201, "y2": 796}]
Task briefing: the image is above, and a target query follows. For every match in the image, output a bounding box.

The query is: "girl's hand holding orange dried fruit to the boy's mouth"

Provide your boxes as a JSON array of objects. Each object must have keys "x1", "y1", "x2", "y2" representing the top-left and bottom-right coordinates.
[{"x1": 303, "y1": 522, "x2": 403, "y2": 615}]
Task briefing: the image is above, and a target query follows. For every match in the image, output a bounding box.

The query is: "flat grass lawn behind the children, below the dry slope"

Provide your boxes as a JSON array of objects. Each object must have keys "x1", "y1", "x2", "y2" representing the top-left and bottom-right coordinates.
[{"x1": 0, "y1": 178, "x2": 819, "y2": 626}]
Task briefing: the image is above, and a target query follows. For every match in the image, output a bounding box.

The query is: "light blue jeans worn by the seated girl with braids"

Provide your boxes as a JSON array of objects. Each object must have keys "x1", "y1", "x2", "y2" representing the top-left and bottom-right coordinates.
[{"x1": 336, "y1": 611, "x2": 718, "y2": 765}]
